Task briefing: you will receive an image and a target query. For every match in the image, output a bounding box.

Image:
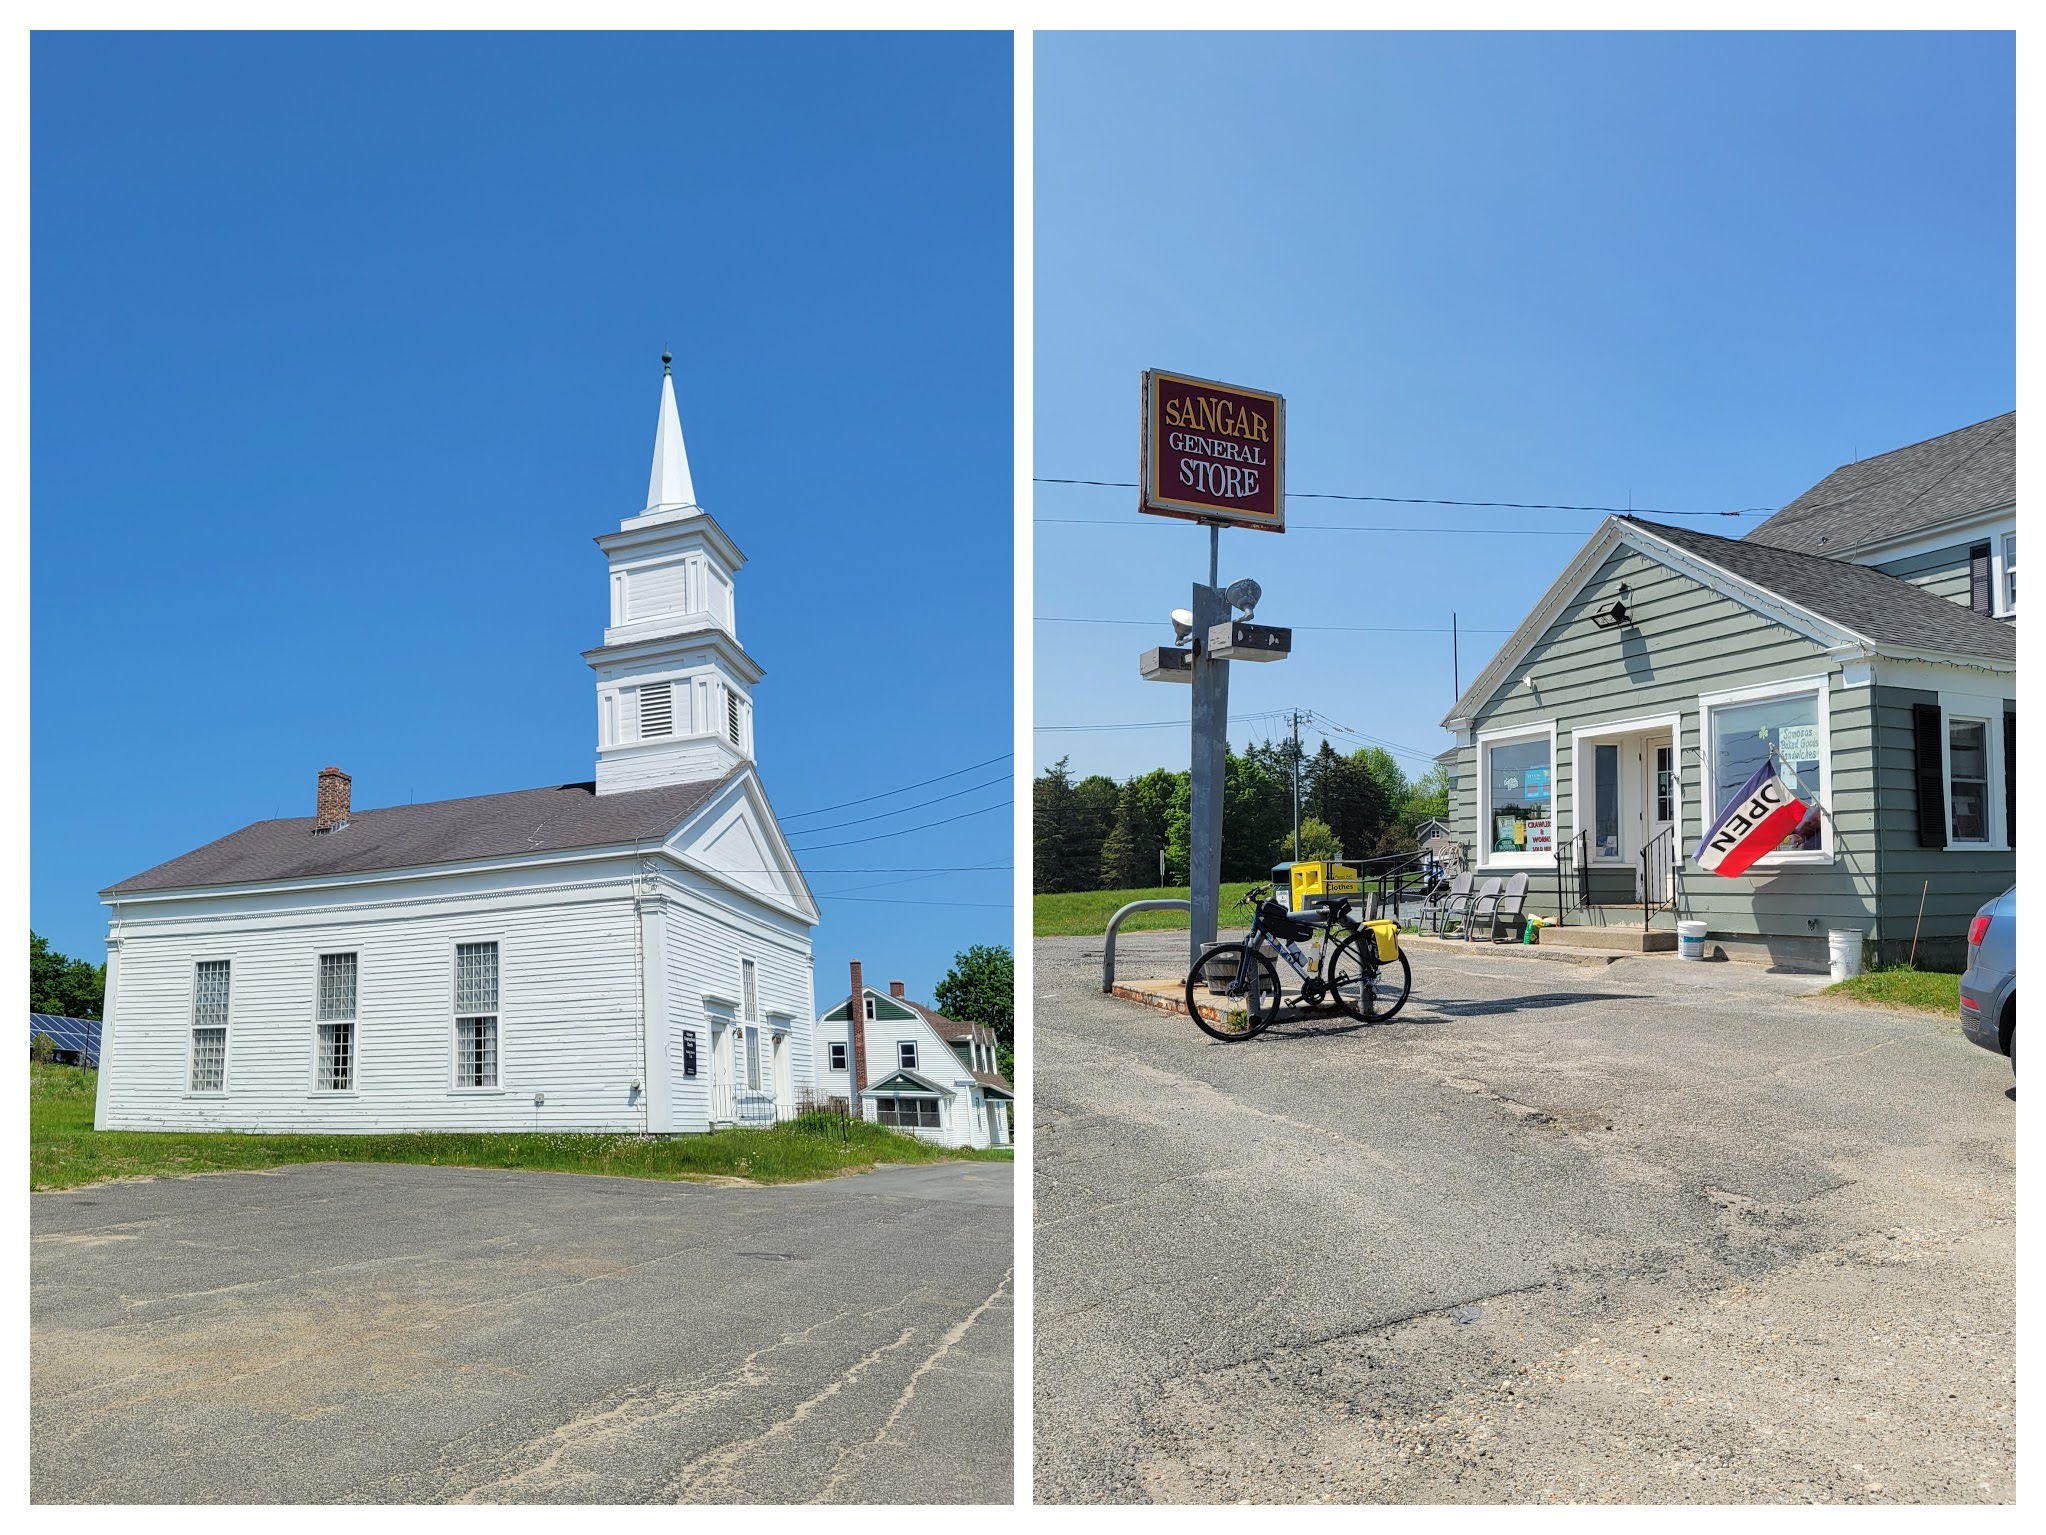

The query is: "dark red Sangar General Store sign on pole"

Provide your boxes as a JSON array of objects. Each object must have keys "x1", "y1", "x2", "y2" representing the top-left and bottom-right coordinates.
[{"x1": 1138, "y1": 368, "x2": 1285, "y2": 532}]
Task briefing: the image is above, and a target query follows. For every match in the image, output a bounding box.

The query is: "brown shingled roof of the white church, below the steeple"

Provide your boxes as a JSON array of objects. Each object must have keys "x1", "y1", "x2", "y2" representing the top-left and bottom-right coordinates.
[{"x1": 100, "y1": 768, "x2": 739, "y2": 896}]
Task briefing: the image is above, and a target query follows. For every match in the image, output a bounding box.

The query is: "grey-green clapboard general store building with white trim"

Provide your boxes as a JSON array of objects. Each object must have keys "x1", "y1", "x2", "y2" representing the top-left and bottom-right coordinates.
[{"x1": 1442, "y1": 413, "x2": 2017, "y2": 968}]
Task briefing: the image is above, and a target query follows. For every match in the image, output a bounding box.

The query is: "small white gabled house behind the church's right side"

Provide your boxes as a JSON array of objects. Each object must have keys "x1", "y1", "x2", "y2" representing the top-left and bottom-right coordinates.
[{"x1": 814, "y1": 960, "x2": 1015, "y2": 1146}]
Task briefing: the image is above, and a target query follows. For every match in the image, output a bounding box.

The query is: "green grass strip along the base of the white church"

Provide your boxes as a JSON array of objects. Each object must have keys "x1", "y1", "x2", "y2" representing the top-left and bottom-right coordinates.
[{"x1": 29, "y1": 1062, "x2": 1015, "y2": 1189}]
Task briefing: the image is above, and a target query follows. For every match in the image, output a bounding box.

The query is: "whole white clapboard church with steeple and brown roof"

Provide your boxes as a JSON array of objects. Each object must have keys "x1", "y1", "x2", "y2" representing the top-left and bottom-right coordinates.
[{"x1": 94, "y1": 356, "x2": 818, "y2": 1134}]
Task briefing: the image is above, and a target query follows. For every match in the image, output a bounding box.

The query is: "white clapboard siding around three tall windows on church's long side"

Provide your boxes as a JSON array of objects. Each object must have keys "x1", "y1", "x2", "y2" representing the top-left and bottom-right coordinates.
[{"x1": 100, "y1": 880, "x2": 644, "y2": 1132}]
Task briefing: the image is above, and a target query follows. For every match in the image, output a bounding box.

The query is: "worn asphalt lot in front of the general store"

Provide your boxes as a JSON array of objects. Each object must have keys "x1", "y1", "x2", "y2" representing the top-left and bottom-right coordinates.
[{"x1": 1033, "y1": 933, "x2": 2015, "y2": 1502}]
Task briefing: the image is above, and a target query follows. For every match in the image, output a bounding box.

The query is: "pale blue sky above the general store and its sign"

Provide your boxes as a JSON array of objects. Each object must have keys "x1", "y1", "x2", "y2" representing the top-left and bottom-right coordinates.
[{"x1": 1033, "y1": 33, "x2": 2015, "y2": 794}]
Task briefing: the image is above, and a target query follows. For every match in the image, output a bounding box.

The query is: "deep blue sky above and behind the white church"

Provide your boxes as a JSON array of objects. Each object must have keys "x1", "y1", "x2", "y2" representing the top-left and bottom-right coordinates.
[{"x1": 31, "y1": 33, "x2": 1013, "y2": 999}]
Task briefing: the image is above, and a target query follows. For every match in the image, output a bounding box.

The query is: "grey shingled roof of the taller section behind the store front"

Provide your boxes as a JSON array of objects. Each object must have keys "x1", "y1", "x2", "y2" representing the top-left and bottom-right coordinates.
[{"x1": 1747, "y1": 411, "x2": 2017, "y2": 555}]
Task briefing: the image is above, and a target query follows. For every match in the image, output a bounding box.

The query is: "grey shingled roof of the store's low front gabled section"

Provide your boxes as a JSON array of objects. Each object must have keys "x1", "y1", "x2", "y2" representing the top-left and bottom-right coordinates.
[{"x1": 1625, "y1": 518, "x2": 2017, "y2": 661}]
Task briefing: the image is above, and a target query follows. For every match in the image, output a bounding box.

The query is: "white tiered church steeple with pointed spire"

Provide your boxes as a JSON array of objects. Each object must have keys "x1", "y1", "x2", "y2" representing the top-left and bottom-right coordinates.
[{"x1": 583, "y1": 352, "x2": 761, "y2": 794}]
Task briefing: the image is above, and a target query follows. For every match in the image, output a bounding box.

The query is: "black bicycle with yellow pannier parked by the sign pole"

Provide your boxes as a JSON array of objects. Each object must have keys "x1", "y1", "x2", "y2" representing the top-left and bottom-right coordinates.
[{"x1": 1187, "y1": 884, "x2": 1414, "y2": 1044}]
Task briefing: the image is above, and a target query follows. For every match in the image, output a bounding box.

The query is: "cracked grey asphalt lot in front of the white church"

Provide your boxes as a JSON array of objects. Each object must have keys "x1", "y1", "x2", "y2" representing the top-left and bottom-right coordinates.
[{"x1": 31, "y1": 1163, "x2": 1015, "y2": 1502}]
